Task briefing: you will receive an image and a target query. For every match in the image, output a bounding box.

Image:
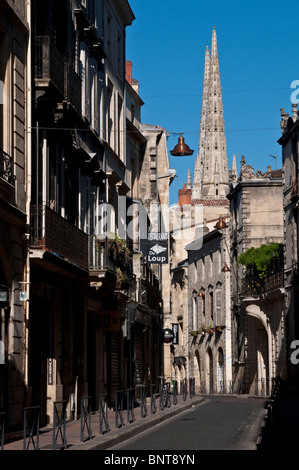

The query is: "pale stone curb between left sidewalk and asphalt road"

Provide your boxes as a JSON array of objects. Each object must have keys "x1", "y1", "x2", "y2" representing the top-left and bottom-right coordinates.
[{"x1": 66, "y1": 397, "x2": 206, "y2": 450}]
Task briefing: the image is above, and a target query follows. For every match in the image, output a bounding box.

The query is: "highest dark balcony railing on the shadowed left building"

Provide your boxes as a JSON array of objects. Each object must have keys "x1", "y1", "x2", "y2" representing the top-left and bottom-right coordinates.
[{"x1": 35, "y1": 36, "x2": 64, "y2": 94}]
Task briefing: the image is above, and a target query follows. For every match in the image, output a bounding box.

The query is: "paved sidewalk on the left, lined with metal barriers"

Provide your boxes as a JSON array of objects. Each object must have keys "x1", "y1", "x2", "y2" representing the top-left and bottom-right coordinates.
[{"x1": 4, "y1": 395, "x2": 205, "y2": 451}]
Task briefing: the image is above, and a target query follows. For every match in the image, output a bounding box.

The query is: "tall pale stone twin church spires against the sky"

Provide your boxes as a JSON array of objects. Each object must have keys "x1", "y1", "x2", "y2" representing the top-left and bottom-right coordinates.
[{"x1": 192, "y1": 28, "x2": 228, "y2": 201}]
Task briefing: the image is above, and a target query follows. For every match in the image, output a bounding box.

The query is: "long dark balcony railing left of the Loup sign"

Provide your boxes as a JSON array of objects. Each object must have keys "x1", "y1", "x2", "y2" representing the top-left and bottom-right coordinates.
[{"x1": 30, "y1": 206, "x2": 88, "y2": 270}]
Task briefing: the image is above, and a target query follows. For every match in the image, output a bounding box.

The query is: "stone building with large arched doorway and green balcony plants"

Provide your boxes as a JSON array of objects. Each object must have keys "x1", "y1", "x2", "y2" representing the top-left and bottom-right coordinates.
[{"x1": 228, "y1": 156, "x2": 286, "y2": 394}]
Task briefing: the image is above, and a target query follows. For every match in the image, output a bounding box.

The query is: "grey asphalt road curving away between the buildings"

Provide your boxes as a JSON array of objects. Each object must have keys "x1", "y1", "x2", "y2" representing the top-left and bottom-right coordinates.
[{"x1": 113, "y1": 396, "x2": 265, "y2": 450}]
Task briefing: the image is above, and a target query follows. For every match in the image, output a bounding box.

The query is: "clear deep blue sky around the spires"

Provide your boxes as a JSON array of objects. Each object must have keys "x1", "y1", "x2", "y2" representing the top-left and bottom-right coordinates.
[{"x1": 126, "y1": 0, "x2": 299, "y2": 204}]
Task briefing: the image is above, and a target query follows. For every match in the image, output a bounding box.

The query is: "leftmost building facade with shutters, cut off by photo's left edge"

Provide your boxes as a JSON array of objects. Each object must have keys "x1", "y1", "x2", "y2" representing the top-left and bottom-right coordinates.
[{"x1": 0, "y1": 0, "x2": 31, "y2": 429}]
